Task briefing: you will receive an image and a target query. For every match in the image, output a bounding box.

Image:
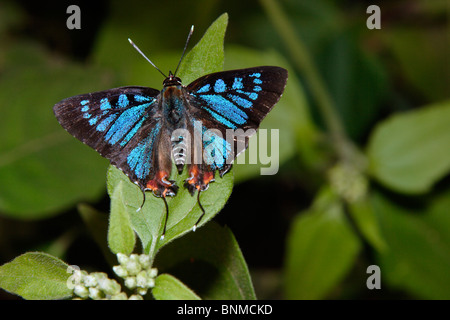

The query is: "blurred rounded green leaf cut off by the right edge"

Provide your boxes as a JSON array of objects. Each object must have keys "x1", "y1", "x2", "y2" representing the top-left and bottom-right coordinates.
[{"x1": 367, "y1": 101, "x2": 450, "y2": 194}]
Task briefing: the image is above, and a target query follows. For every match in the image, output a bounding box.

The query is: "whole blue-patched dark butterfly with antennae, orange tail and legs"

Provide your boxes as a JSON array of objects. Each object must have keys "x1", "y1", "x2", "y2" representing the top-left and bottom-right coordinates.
[{"x1": 53, "y1": 28, "x2": 288, "y2": 238}]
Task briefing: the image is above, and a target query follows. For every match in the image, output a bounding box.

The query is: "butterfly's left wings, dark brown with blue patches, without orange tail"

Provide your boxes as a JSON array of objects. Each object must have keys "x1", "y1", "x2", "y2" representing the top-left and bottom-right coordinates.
[{"x1": 53, "y1": 86, "x2": 161, "y2": 188}]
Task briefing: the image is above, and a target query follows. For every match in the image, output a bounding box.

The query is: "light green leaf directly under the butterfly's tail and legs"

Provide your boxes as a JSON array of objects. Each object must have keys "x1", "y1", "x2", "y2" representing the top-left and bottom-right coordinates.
[{"x1": 108, "y1": 166, "x2": 233, "y2": 256}]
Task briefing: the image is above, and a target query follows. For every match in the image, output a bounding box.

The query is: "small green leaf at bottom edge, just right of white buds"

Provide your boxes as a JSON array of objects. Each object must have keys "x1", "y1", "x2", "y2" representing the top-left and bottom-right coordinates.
[{"x1": 152, "y1": 274, "x2": 201, "y2": 300}]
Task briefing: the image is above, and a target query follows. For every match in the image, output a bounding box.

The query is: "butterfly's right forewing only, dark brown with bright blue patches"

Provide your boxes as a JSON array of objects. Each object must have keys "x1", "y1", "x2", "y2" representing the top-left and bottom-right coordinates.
[{"x1": 187, "y1": 67, "x2": 287, "y2": 129}]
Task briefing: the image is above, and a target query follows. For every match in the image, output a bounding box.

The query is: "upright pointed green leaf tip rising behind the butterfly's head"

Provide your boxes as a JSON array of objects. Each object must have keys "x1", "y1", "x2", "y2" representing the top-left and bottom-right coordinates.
[{"x1": 178, "y1": 13, "x2": 228, "y2": 83}]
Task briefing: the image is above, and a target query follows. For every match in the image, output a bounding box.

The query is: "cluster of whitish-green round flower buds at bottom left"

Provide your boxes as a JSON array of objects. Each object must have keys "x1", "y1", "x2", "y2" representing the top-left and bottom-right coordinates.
[{"x1": 67, "y1": 253, "x2": 158, "y2": 300}]
